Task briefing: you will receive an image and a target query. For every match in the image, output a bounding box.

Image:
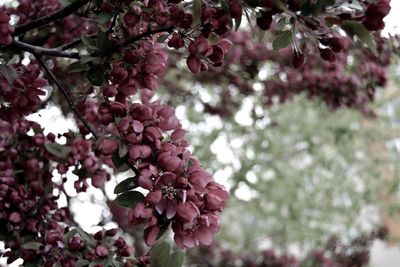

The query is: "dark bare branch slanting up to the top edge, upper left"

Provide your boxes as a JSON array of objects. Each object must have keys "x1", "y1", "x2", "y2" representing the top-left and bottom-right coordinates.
[{"x1": 14, "y1": 0, "x2": 90, "y2": 36}]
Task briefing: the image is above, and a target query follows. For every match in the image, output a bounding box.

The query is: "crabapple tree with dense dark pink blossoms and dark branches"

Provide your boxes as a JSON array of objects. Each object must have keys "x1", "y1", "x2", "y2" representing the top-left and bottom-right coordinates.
[{"x1": 0, "y1": 0, "x2": 390, "y2": 266}]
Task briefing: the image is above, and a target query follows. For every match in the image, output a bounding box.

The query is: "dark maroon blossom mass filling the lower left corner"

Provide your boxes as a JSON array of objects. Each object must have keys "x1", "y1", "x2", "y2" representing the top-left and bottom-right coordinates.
[{"x1": 0, "y1": 119, "x2": 136, "y2": 267}]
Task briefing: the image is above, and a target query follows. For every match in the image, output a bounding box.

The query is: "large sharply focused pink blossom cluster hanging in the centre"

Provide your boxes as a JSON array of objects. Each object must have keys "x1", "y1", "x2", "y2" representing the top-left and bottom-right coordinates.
[{"x1": 99, "y1": 102, "x2": 228, "y2": 248}]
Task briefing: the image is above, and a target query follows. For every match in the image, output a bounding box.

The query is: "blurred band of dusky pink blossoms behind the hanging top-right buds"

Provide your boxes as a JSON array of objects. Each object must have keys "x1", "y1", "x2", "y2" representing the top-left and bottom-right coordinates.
[{"x1": 163, "y1": 31, "x2": 391, "y2": 117}]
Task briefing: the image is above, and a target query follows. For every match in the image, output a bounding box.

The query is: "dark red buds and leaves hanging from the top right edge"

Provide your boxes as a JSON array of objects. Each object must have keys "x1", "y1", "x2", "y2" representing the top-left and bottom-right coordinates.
[{"x1": 241, "y1": 0, "x2": 390, "y2": 63}]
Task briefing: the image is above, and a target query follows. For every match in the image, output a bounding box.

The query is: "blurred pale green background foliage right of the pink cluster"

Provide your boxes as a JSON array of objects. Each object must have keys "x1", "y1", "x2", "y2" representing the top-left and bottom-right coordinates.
[{"x1": 156, "y1": 61, "x2": 399, "y2": 251}]
